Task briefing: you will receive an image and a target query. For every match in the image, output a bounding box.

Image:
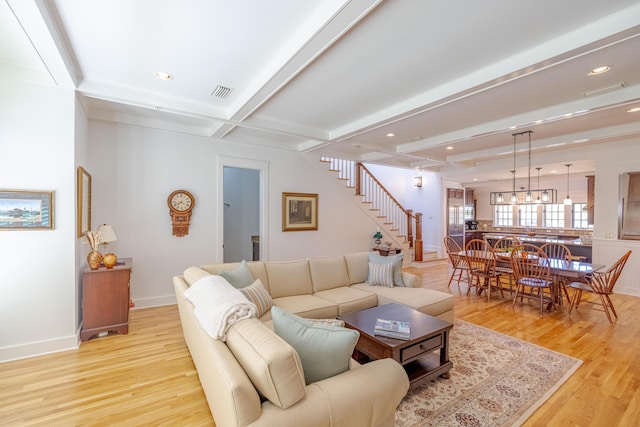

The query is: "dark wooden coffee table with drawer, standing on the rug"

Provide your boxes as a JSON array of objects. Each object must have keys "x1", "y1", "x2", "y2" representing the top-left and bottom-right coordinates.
[{"x1": 338, "y1": 303, "x2": 453, "y2": 385}]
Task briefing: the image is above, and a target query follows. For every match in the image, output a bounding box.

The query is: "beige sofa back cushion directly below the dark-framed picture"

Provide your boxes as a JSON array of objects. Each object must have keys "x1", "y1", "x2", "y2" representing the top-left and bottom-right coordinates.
[{"x1": 265, "y1": 259, "x2": 313, "y2": 298}]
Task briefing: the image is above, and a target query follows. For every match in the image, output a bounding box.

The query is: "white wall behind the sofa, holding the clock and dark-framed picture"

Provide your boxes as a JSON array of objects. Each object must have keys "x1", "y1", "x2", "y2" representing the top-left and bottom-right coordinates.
[{"x1": 87, "y1": 120, "x2": 382, "y2": 307}]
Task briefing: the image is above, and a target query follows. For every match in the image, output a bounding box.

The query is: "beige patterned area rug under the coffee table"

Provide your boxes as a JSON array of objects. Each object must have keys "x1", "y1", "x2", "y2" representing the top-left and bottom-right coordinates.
[{"x1": 396, "y1": 320, "x2": 582, "y2": 427}]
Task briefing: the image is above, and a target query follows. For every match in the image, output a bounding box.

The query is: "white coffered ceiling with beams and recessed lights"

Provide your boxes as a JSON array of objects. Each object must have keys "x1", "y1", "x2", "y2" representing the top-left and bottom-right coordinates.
[{"x1": 0, "y1": 0, "x2": 640, "y2": 183}]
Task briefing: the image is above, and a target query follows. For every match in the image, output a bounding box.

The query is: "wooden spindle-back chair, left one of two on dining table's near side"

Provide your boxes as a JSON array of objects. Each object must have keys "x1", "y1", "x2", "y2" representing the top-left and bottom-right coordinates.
[{"x1": 465, "y1": 239, "x2": 504, "y2": 301}]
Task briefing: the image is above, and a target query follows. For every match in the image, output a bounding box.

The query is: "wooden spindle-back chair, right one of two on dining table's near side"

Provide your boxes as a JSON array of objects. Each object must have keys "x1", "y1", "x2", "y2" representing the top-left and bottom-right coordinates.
[{"x1": 511, "y1": 243, "x2": 555, "y2": 315}]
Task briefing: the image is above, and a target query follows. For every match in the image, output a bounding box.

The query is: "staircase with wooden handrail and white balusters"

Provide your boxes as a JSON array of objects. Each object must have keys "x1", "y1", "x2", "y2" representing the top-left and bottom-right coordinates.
[{"x1": 320, "y1": 157, "x2": 423, "y2": 262}]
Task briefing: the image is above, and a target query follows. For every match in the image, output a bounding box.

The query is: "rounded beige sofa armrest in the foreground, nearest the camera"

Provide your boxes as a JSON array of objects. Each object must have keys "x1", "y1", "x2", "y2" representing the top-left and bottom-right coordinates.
[{"x1": 251, "y1": 359, "x2": 409, "y2": 427}]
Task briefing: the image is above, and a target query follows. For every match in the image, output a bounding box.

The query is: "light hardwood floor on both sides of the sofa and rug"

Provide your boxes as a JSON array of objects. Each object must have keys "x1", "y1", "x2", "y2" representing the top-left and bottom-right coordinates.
[{"x1": 0, "y1": 263, "x2": 640, "y2": 426}]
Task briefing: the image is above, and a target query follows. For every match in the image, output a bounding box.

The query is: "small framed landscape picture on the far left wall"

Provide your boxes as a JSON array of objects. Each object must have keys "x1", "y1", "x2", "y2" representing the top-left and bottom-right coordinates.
[{"x1": 0, "y1": 190, "x2": 54, "y2": 230}]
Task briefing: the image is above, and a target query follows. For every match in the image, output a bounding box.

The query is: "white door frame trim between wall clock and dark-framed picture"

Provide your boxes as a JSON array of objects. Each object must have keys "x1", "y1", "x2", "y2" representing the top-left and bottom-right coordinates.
[{"x1": 214, "y1": 155, "x2": 269, "y2": 263}]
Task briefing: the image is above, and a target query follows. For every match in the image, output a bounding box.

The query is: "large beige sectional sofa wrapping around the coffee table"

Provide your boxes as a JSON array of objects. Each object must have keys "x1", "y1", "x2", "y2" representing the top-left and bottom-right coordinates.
[{"x1": 173, "y1": 252, "x2": 453, "y2": 427}]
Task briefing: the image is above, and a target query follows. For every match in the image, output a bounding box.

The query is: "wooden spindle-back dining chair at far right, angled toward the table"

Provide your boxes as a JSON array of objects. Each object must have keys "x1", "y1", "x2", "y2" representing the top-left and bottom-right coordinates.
[{"x1": 569, "y1": 251, "x2": 632, "y2": 323}]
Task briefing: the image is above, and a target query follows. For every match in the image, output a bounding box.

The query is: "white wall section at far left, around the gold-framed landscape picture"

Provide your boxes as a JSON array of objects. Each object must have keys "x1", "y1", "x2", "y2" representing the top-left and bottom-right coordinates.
[{"x1": 0, "y1": 78, "x2": 82, "y2": 361}]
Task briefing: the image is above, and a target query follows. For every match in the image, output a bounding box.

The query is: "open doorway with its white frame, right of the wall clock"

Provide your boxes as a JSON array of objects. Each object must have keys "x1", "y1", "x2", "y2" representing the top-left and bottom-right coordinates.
[{"x1": 216, "y1": 156, "x2": 268, "y2": 262}]
